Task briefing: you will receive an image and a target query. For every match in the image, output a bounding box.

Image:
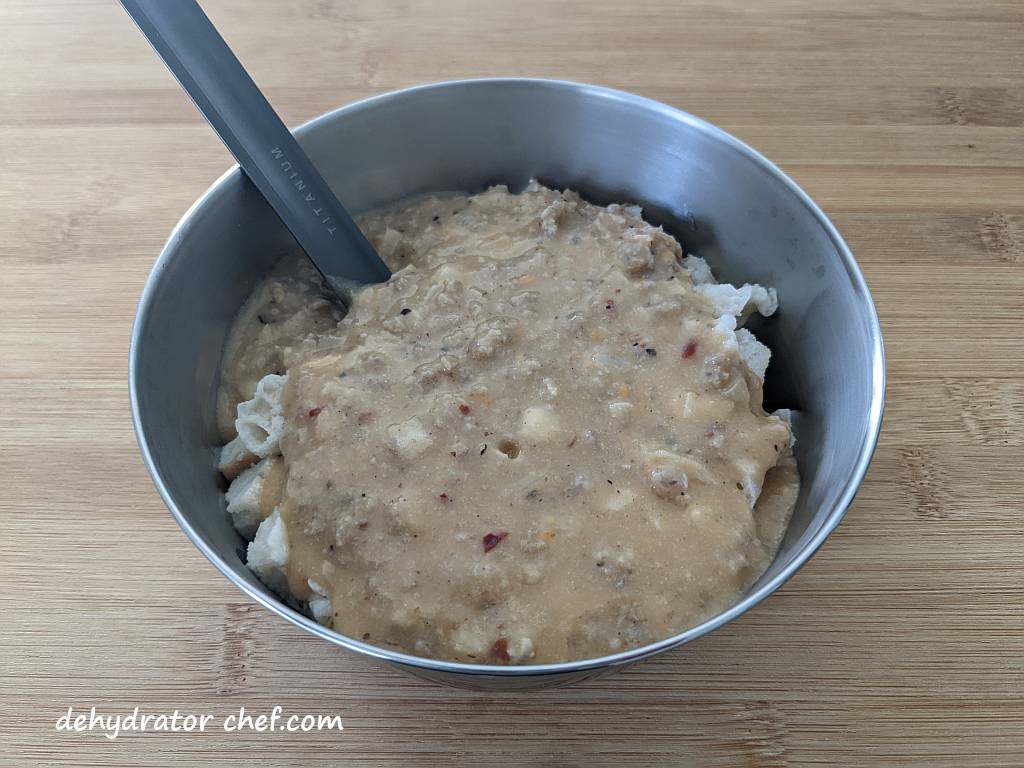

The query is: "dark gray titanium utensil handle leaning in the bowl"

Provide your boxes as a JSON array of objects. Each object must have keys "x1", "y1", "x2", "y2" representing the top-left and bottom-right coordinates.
[{"x1": 121, "y1": 0, "x2": 391, "y2": 305}]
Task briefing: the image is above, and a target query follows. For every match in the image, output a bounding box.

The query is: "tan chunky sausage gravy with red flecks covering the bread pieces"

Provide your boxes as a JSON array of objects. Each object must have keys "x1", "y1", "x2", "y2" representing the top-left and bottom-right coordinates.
[{"x1": 220, "y1": 184, "x2": 799, "y2": 664}]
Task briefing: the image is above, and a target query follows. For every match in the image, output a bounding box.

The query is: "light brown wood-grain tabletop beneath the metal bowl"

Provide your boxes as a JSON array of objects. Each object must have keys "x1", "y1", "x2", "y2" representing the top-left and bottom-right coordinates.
[{"x1": 0, "y1": 0, "x2": 1024, "y2": 768}]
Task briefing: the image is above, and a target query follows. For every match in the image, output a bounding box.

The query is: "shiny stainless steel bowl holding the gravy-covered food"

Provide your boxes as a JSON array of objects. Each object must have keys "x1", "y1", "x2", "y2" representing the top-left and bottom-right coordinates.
[{"x1": 130, "y1": 79, "x2": 885, "y2": 689}]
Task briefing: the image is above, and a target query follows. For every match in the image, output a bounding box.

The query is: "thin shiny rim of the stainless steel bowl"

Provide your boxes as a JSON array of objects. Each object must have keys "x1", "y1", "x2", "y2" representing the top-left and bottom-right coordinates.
[{"x1": 128, "y1": 78, "x2": 885, "y2": 677}]
